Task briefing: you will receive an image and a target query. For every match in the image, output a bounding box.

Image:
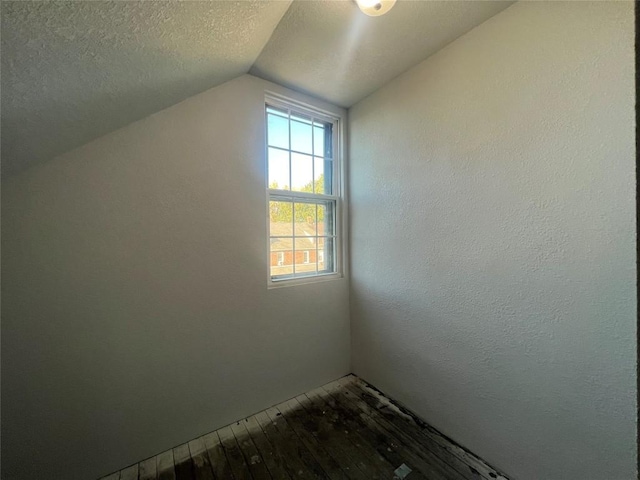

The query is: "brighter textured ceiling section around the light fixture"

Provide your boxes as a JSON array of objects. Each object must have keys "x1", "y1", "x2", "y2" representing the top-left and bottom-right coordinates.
[{"x1": 250, "y1": 0, "x2": 513, "y2": 107}]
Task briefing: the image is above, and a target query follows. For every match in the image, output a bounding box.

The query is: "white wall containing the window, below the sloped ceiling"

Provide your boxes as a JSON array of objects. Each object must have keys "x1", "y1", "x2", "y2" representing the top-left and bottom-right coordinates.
[{"x1": 2, "y1": 76, "x2": 349, "y2": 480}]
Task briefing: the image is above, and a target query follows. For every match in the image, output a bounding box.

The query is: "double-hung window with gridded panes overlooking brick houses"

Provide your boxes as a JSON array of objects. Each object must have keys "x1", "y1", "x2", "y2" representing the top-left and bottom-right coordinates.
[{"x1": 265, "y1": 98, "x2": 340, "y2": 284}]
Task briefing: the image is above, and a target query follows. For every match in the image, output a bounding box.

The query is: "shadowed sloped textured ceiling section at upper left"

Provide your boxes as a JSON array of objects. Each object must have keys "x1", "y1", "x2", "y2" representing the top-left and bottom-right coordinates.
[{"x1": 1, "y1": 0, "x2": 291, "y2": 174}]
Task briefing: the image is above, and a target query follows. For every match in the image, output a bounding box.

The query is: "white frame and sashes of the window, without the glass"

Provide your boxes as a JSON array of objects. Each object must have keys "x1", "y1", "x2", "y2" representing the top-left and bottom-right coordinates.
[{"x1": 263, "y1": 92, "x2": 347, "y2": 288}]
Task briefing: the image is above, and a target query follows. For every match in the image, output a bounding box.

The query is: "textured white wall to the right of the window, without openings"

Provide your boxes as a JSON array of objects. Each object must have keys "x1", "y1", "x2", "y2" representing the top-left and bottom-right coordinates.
[{"x1": 349, "y1": 2, "x2": 636, "y2": 480}]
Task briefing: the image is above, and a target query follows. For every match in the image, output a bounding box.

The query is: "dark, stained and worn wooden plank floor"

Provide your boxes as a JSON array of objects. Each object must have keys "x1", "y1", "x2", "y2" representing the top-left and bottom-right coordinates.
[{"x1": 103, "y1": 375, "x2": 506, "y2": 480}]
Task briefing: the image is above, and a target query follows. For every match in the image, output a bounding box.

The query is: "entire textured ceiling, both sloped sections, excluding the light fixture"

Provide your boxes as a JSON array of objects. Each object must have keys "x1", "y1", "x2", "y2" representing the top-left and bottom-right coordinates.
[{"x1": 1, "y1": 0, "x2": 512, "y2": 175}]
